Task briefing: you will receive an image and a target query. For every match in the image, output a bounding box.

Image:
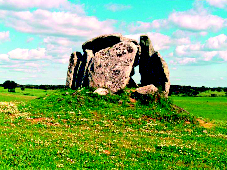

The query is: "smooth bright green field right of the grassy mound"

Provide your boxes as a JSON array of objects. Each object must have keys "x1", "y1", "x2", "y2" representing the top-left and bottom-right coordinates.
[{"x1": 171, "y1": 97, "x2": 227, "y2": 121}]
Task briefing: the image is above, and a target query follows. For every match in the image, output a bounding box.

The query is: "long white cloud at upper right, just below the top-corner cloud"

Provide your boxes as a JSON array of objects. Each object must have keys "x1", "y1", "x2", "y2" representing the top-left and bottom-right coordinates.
[{"x1": 129, "y1": 6, "x2": 227, "y2": 32}]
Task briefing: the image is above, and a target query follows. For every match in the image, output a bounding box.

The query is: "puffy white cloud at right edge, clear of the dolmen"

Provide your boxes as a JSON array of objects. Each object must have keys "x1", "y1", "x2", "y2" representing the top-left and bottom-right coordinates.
[{"x1": 169, "y1": 34, "x2": 227, "y2": 65}]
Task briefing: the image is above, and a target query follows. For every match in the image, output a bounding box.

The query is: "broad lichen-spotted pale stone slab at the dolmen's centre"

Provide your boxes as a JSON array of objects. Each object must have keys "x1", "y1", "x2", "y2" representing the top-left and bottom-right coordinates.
[{"x1": 89, "y1": 42, "x2": 137, "y2": 92}]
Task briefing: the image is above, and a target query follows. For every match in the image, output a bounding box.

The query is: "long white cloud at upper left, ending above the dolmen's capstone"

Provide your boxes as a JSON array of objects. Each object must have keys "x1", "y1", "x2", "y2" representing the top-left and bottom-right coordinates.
[{"x1": 0, "y1": 9, "x2": 114, "y2": 40}]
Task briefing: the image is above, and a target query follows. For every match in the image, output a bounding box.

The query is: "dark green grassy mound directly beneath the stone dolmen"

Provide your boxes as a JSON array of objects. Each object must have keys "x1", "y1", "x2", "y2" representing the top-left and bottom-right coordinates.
[{"x1": 19, "y1": 89, "x2": 195, "y2": 124}]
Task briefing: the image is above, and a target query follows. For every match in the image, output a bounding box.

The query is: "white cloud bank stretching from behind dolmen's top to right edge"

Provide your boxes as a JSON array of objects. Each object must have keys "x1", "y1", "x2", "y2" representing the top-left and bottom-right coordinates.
[{"x1": 126, "y1": 32, "x2": 227, "y2": 65}]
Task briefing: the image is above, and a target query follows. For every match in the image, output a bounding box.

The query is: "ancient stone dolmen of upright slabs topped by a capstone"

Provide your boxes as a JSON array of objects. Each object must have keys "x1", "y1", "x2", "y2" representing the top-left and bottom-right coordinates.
[{"x1": 66, "y1": 34, "x2": 170, "y2": 97}]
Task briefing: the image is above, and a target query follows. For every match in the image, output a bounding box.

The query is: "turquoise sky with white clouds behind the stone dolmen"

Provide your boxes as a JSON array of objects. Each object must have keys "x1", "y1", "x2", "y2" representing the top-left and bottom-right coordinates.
[{"x1": 0, "y1": 0, "x2": 227, "y2": 87}]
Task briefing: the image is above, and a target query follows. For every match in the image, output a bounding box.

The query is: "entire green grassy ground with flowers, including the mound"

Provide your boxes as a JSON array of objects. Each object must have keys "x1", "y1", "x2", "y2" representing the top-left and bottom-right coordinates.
[{"x1": 0, "y1": 89, "x2": 227, "y2": 169}]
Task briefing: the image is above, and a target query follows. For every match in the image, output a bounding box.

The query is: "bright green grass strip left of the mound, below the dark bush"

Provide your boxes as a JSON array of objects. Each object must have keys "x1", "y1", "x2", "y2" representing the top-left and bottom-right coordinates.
[{"x1": 0, "y1": 87, "x2": 54, "y2": 102}]
